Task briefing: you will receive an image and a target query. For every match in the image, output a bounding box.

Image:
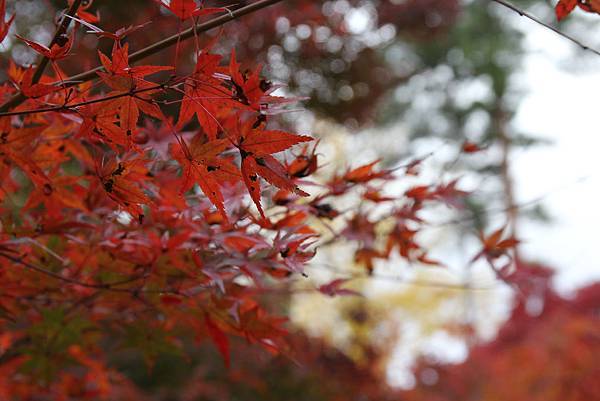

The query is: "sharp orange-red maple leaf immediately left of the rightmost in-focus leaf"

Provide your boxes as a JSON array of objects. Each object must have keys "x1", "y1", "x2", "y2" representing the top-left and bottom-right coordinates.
[{"x1": 171, "y1": 135, "x2": 241, "y2": 217}]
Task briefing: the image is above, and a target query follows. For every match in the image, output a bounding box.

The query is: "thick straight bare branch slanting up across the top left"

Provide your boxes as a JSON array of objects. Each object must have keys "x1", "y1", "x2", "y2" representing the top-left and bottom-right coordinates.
[{"x1": 0, "y1": 0, "x2": 283, "y2": 113}]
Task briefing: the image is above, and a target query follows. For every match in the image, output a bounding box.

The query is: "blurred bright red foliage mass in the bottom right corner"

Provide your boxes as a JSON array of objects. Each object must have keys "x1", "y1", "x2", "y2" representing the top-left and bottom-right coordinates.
[{"x1": 402, "y1": 265, "x2": 600, "y2": 401}]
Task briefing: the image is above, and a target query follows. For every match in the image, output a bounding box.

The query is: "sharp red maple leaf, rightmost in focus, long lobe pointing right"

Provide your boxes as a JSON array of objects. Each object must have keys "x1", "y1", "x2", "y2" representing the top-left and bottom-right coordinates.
[{"x1": 229, "y1": 122, "x2": 313, "y2": 218}]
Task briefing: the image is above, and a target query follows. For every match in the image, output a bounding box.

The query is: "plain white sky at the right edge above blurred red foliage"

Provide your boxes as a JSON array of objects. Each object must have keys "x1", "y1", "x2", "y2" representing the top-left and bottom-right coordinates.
[{"x1": 512, "y1": 10, "x2": 600, "y2": 291}]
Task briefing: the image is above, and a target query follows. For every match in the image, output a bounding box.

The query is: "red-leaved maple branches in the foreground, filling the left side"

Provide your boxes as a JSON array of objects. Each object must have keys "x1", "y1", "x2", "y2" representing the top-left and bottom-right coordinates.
[{"x1": 0, "y1": 0, "x2": 592, "y2": 400}]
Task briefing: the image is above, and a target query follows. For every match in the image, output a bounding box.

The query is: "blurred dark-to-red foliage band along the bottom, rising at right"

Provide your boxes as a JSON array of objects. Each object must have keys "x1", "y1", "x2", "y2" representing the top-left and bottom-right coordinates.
[{"x1": 89, "y1": 264, "x2": 600, "y2": 401}]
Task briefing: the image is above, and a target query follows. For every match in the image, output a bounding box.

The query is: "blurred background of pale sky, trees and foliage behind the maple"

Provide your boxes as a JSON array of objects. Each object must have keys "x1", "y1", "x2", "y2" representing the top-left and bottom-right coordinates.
[{"x1": 0, "y1": 0, "x2": 600, "y2": 401}]
